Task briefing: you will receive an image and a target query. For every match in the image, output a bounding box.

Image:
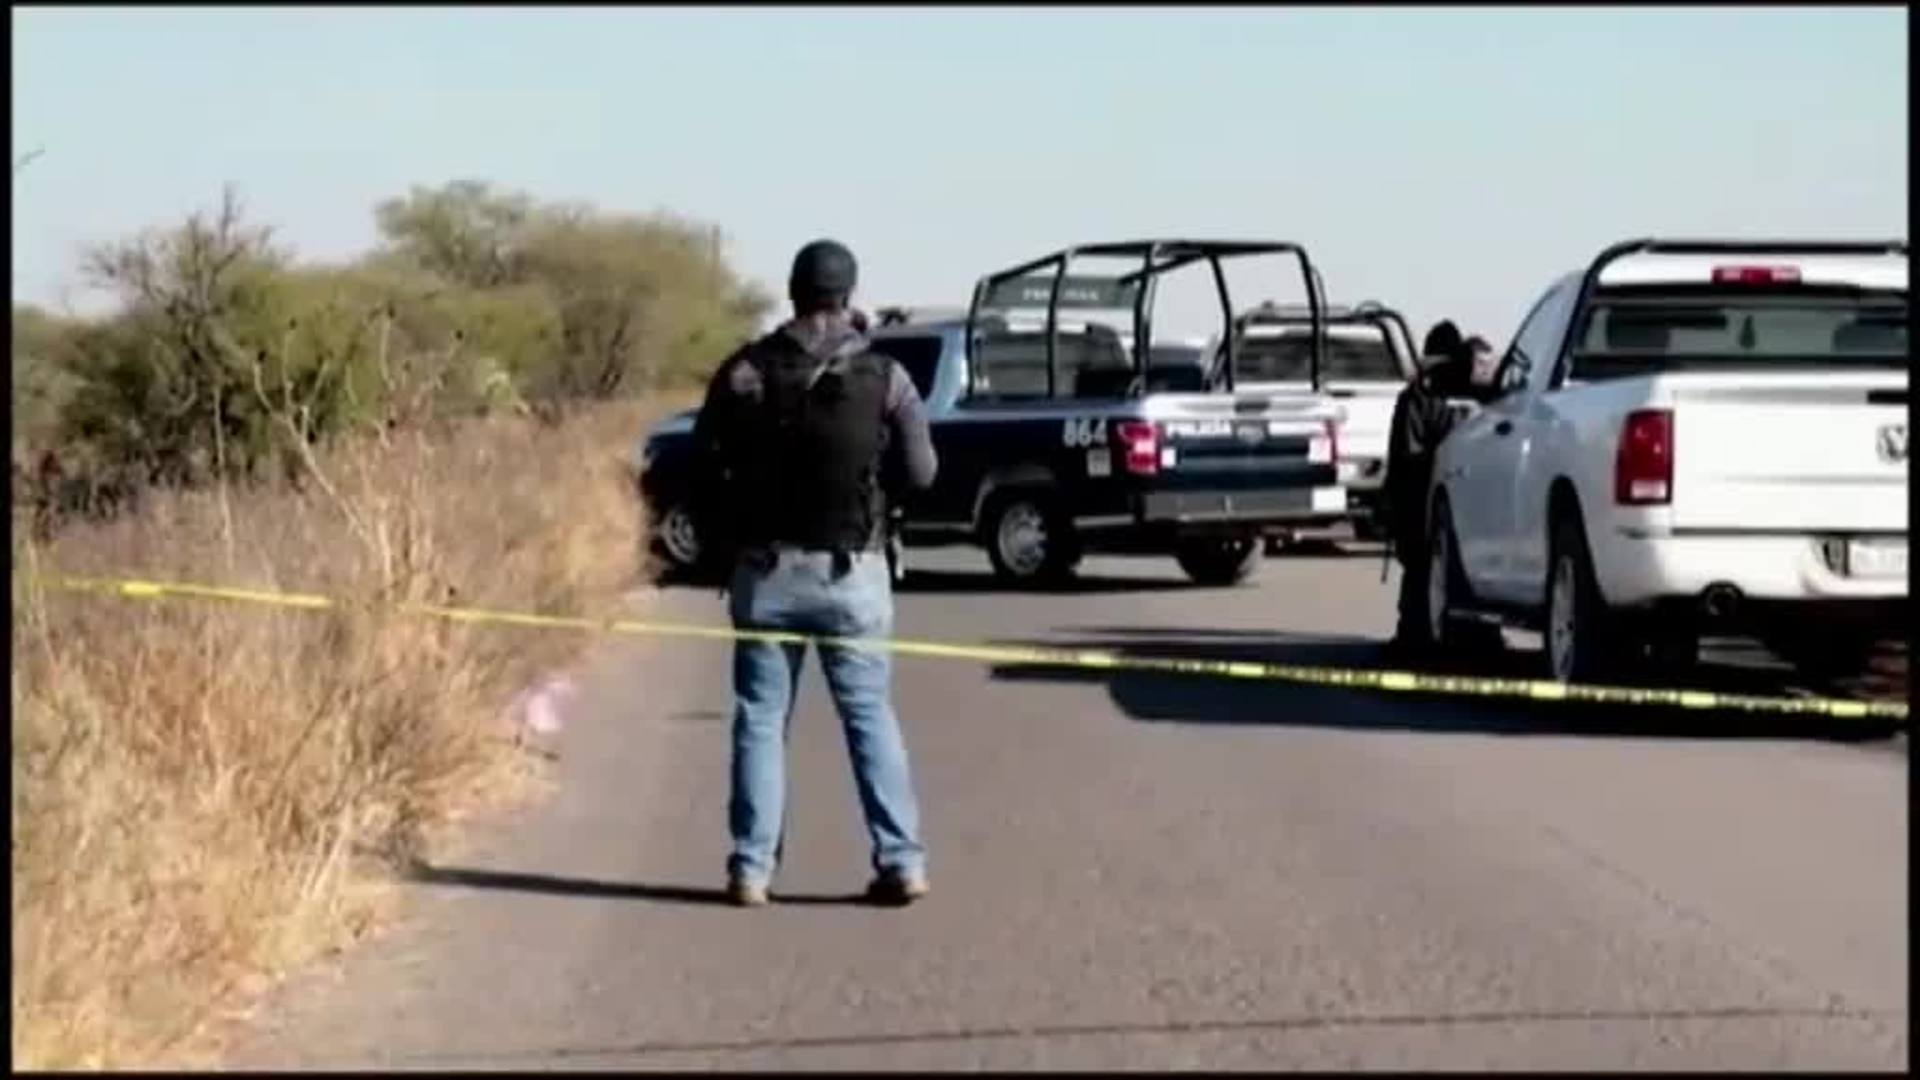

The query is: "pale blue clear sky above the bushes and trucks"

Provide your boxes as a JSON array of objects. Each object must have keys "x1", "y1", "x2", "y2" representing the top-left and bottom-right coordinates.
[{"x1": 12, "y1": 8, "x2": 1908, "y2": 340}]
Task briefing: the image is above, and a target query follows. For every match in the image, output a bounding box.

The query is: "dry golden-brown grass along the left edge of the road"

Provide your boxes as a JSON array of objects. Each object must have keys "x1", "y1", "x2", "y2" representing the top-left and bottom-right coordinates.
[{"x1": 12, "y1": 397, "x2": 675, "y2": 1068}]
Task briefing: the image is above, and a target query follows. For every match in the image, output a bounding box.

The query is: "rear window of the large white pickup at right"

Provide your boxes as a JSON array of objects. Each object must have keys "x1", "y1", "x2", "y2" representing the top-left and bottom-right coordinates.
[{"x1": 1572, "y1": 286, "x2": 1907, "y2": 377}]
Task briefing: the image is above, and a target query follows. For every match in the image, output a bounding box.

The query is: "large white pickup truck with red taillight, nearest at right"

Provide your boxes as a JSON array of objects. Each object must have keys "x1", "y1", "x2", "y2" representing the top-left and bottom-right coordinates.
[{"x1": 1425, "y1": 240, "x2": 1908, "y2": 682}]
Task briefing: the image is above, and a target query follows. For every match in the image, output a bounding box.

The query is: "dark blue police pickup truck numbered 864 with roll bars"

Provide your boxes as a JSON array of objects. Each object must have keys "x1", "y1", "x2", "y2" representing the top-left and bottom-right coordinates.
[{"x1": 637, "y1": 240, "x2": 1346, "y2": 584}]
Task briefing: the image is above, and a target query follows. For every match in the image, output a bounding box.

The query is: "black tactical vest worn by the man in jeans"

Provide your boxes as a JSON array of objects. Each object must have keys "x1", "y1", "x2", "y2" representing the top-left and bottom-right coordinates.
[{"x1": 735, "y1": 334, "x2": 891, "y2": 552}]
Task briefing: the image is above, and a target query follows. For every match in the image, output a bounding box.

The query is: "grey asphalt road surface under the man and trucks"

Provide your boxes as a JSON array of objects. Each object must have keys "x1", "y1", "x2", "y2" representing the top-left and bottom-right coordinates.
[{"x1": 232, "y1": 552, "x2": 1908, "y2": 1068}]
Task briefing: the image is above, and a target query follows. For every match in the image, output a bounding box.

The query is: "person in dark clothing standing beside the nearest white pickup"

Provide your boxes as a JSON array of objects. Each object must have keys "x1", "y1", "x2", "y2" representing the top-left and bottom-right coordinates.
[{"x1": 1386, "y1": 319, "x2": 1473, "y2": 651}]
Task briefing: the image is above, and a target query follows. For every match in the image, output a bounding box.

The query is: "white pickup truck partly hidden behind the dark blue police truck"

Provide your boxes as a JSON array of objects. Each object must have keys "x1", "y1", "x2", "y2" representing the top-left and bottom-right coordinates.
[{"x1": 1213, "y1": 300, "x2": 1419, "y2": 540}]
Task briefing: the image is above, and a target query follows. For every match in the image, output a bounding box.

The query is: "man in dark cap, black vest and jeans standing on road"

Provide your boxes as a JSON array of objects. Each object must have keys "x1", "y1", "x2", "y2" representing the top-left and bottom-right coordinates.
[{"x1": 693, "y1": 240, "x2": 935, "y2": 907}]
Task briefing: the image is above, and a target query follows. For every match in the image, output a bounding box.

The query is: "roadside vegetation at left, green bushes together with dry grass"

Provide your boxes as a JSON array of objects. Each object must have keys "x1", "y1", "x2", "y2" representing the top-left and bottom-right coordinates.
[{"x1": 10, "y1": 183, "x2": 768, "y2": 1068}]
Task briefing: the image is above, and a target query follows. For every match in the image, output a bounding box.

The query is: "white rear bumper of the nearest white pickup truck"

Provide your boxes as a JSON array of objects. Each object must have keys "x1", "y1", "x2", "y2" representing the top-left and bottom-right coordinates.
[{"x1": 1594, "y1": 530, "x2": 1907, "y2": 607}]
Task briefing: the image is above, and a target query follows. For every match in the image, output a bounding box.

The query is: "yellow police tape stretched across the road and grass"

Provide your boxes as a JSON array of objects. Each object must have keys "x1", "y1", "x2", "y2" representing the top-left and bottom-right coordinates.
[{"x1": 46, "y1": 577, "x2": 1907, "y2": 721}]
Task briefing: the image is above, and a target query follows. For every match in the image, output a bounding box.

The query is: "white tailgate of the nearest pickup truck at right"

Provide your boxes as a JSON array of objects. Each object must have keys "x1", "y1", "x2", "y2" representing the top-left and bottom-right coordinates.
[{"x1": 1670, "y1": 371, "x2": 1907, "y2": 532}]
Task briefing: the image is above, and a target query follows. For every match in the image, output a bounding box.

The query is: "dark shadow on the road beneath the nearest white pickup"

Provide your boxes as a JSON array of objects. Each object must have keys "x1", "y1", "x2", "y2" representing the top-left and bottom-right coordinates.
[{"x1": 993, "y1": 626, "x2": 1899, "y2": 742}]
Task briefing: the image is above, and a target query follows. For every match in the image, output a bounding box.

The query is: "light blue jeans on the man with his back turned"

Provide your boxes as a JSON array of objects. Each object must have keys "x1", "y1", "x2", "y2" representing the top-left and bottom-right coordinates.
[{"x1": 728, "y1": 550, "x2": 925, "y2": 884}]
